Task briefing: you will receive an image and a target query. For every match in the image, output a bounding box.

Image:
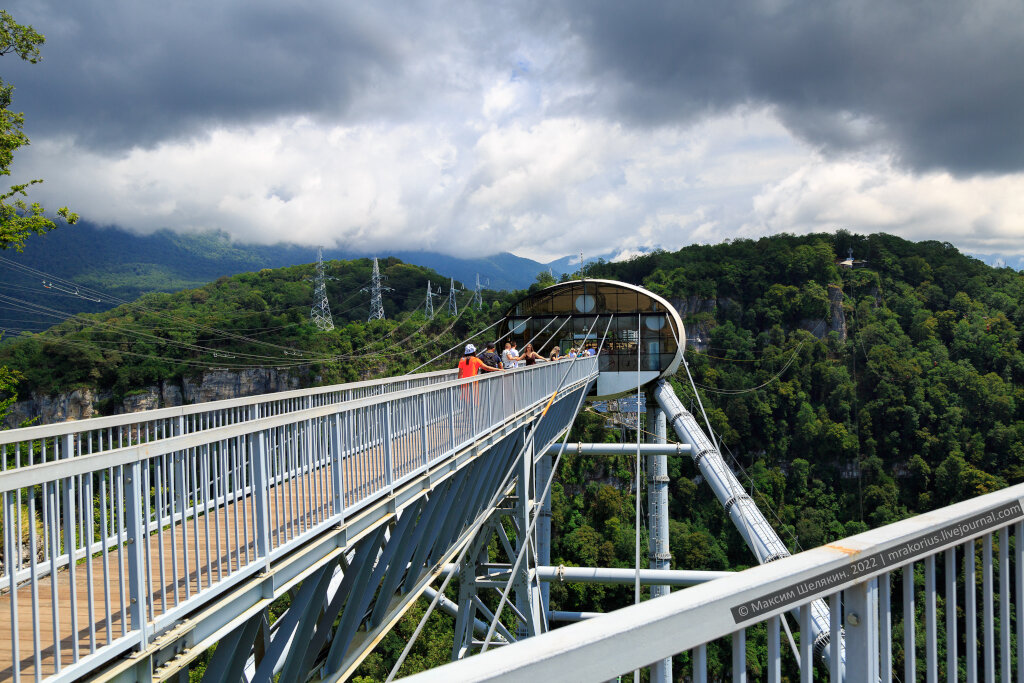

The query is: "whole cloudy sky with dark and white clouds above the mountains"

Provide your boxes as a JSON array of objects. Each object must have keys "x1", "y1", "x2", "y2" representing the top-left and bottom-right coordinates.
[{"x1": 6, "y1": 0, "x2": 1024, "y2": 260}]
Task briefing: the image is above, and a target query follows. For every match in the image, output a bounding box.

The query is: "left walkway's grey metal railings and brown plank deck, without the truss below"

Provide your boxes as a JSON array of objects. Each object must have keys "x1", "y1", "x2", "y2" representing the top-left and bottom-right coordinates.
[{"x1": 0, "y1": 358, "x2": 597, "y2": 681}]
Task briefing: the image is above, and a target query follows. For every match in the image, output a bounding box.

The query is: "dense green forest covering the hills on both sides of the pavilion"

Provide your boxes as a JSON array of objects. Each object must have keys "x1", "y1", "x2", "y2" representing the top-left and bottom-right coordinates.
[{"x1": 0, "y1": 230, "x2": 1024, "y2": 680}]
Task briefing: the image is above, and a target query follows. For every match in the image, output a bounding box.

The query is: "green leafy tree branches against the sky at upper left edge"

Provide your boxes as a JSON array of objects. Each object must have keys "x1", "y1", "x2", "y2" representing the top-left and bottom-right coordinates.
[{"x1": 0, "y1": 9, "x2": 78, "y2": 251}]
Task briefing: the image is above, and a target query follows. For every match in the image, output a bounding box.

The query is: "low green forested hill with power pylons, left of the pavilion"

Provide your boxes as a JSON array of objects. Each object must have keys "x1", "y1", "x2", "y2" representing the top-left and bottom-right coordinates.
[{"x1": 0, "y1": 259, "x2": 512, "y2": 405}]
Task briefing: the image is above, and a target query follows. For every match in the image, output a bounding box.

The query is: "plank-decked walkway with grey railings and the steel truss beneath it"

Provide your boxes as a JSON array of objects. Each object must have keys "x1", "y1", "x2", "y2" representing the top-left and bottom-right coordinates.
[{"x1": 0, "y1": 357, "x2": 598, "y2": 681}]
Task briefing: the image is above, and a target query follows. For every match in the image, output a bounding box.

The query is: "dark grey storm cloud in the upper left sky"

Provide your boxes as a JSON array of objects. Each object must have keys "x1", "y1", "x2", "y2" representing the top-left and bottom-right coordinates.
[{"x1": 0, "y1": 0, "x2": 400, "y2": 148}]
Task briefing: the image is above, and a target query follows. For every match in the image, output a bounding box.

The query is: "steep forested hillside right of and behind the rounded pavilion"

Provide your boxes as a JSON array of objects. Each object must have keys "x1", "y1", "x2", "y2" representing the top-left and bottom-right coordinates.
[{"x1": 532, "y1": 231, "x2": 1024, "y2": 671}]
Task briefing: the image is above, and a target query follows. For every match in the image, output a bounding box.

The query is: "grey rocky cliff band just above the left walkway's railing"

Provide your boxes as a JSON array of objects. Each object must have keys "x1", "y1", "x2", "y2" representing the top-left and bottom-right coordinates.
[{"x1": 4, "y1": 368, "x2": 300, "y2": 428}]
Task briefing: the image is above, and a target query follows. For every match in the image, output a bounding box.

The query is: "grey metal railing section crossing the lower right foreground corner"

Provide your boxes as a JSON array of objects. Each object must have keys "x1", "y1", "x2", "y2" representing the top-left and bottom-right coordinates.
[{"x1": 411, "y1": 484, "x2": 1024, "y2": 683}]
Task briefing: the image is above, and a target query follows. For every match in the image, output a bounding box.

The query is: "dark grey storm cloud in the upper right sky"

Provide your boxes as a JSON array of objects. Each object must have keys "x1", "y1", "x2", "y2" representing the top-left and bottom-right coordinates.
[{"x1": 532, "y1": 0, "x2": 1024, "y2": 173}]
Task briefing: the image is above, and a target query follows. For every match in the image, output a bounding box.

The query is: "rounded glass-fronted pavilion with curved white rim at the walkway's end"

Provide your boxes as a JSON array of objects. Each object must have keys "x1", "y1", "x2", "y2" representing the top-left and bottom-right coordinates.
[{"x1": 503, "y1": 280, "x2": 686, "y2": 397}]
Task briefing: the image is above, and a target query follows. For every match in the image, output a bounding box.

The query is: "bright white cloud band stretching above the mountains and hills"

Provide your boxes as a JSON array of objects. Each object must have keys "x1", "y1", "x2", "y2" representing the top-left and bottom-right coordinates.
[{"x1": 15, "y1": 104, "x2": 1024, "y2": 260}]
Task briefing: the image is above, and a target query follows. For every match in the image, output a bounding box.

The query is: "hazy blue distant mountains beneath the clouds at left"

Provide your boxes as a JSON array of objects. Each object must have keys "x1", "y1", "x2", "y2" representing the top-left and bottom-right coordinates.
[{"x1": 0, "y1": 221, "x2": 606, "y2": 335}]
